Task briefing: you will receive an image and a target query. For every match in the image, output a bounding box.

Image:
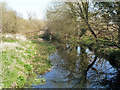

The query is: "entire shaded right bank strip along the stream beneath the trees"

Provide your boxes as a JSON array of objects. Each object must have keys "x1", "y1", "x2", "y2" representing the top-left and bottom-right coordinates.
[{"x1": 51, "y1": 36, "x2": 120, "y2": 68}]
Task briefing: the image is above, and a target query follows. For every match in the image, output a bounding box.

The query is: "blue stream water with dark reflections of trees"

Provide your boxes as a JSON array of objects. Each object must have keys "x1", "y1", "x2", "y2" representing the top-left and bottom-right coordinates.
[{"x1": 33, "y1": 47, "x2": 120, "y2": 88}]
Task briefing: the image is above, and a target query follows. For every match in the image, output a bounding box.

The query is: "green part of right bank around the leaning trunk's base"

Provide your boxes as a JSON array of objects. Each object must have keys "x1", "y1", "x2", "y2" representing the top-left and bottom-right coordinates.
[{"x1": 80, "y1": 36, "x2": 120, "y2": 69}]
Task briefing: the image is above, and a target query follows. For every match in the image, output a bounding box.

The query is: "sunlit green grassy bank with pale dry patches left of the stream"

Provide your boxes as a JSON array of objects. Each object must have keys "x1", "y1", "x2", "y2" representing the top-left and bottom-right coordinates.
[{"x1": 0, "y1": 34, "x2": 55, "y2": 88}]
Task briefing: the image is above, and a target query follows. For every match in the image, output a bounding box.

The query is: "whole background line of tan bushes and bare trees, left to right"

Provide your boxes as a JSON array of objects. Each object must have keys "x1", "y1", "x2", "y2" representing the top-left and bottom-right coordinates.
[{"x1": 0, "y1": 0, "x2": 120, "y2": 48}]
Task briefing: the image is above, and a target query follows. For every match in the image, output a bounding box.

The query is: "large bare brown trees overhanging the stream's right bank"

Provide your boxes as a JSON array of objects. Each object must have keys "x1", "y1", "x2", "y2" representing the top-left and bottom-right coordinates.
[{"x1": 46, "y1": 0, "x2": 120, "y2": 48}]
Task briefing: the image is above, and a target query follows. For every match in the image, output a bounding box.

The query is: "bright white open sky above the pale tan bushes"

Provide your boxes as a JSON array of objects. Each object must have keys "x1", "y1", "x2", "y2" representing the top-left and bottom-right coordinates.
[{"x1": 2, "y1": 0, "x2": 51, "y2": 19}]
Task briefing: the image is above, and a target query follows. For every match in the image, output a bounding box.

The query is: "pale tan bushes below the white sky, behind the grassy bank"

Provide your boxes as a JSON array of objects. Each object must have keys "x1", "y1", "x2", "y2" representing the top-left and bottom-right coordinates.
[{"x1": 0, "y1": 3, "x2": 45, "y2": 34}]
